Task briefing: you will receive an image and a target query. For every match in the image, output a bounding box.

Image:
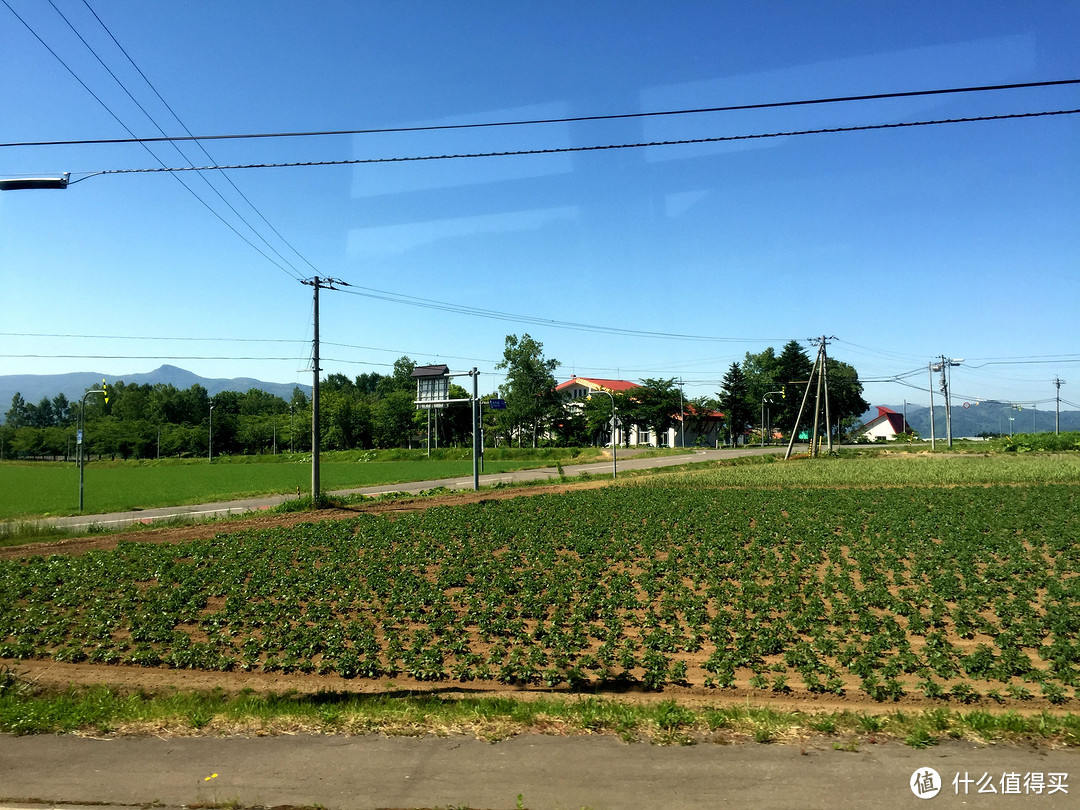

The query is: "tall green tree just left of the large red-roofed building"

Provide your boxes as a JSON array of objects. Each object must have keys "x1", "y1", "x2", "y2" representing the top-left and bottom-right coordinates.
[{"x1": 496, "y1": 334, "x2": 562, "y2": 447}]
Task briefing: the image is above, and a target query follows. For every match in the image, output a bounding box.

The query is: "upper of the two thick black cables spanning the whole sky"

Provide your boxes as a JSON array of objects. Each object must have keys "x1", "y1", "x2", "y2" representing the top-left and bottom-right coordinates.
[{"x1": 0, "y1": 77, "x2": 1080, "y2": 147}]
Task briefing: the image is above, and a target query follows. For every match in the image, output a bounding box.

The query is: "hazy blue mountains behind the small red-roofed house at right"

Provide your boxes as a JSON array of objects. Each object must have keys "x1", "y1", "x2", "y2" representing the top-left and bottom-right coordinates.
[{"x1": 863, "y1": 401, "x2": 1080, "y2": 438}]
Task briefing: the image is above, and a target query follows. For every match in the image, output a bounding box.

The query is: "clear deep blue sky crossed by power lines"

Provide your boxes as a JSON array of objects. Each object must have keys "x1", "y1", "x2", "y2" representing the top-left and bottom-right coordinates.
[{"x1": 0, "y1": 0, "x2": 1080, "y2": 405}]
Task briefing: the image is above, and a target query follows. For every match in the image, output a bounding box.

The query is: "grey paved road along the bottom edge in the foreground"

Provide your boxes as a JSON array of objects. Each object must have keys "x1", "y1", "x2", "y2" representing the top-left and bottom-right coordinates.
[{"x1": 0, "y1": 734, "x2": 1080, "y2": 810}]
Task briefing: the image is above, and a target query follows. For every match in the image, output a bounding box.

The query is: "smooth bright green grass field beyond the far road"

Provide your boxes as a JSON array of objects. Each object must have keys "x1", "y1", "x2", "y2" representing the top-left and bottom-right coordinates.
[{"x1": 0, "y1": 450, "x2": 613, "y2": 519}]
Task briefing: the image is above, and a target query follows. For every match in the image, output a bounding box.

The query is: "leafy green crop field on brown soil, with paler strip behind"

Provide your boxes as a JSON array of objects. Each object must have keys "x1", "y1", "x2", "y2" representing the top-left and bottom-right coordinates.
[{"x1": 0, "y1": 456, "x2": 1080, "y2": 707}]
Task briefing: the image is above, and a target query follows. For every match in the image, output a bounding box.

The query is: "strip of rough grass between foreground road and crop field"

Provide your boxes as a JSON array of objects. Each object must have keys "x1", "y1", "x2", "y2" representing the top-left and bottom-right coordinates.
[{"x1": 0, "y1": 669, "x2": 1080, "y2": 751}]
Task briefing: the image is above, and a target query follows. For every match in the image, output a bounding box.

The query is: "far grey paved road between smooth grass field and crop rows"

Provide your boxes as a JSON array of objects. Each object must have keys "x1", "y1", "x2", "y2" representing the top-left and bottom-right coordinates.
[{"x1": 28, "y1": 447, "x2": 784, "y2": 529}]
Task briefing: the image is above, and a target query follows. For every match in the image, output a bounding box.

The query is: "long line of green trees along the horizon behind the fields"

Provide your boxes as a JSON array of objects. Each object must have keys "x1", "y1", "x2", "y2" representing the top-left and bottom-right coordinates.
[{"x1": 0, "y1": 334, "x2": 869, "y2": 459}]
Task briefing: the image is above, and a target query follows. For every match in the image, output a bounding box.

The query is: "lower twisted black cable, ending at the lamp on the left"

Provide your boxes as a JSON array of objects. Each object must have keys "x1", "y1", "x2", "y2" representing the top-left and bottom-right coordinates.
[{"x1": 69, "y1": 109, "x2": 1080, "y2": 185}]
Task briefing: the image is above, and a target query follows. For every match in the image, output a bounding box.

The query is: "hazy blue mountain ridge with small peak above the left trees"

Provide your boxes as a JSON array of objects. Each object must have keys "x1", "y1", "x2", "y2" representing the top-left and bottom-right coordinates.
[{"x1": 0, "y1": 365, "x2": 311, "y2": 419}]
